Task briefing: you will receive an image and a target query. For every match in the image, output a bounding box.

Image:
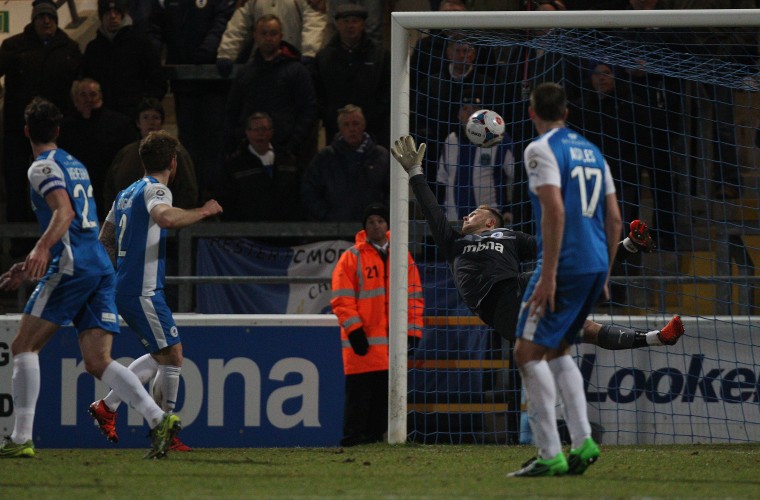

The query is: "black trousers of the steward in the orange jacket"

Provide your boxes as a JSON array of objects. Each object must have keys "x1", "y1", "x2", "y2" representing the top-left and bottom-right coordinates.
[{"x1": 340, "y1": 370, "x2": 388, "y2": 446}]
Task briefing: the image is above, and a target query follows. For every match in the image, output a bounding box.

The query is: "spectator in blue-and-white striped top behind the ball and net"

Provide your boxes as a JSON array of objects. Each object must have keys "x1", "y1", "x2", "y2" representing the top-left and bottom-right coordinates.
[{"x1": 436, "y1": 96, "x2": 515, "y2": 222}]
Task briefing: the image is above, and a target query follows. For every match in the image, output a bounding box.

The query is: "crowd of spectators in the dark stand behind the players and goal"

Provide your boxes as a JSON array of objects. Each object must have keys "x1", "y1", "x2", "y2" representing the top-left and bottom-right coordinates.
[{"x1": 0, "y1": 0, "x2": 757, "y2": 232}]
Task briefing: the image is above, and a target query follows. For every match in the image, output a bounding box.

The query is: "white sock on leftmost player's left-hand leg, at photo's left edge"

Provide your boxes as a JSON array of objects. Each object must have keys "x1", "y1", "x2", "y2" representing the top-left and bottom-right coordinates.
[{"x1": 11, "y1": 352, "x2": 40, "y2": 444}]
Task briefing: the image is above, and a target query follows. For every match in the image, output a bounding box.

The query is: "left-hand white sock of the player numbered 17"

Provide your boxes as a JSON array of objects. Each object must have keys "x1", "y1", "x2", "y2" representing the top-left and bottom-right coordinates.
[{"x1": 520, "y1": 360, "x2": 562, "y2": 459}]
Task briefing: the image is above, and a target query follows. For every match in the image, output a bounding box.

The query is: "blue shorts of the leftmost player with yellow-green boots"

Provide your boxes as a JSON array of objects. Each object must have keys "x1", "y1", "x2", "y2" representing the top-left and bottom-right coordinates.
[{"x1": 24, "y1": 272, "x2": 119, "y2": 333}]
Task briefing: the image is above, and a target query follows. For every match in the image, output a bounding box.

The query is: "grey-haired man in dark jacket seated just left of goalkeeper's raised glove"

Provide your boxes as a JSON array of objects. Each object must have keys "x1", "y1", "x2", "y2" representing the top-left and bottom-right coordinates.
[{"x1": 301, "y1": 104, "x2": 390, "y2": 222}]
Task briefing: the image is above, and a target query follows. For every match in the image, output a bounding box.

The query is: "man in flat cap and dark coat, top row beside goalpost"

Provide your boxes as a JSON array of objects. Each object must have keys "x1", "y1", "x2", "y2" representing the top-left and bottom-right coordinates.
[{"x1": 312, "y1": 4, "x2": 391, "y2": 148}]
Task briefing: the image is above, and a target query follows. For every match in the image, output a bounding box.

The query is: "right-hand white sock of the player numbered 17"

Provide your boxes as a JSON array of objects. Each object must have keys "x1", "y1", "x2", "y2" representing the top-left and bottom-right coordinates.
[{"x1": 549, "y1": 354, "x2": 591, "y2": 448}]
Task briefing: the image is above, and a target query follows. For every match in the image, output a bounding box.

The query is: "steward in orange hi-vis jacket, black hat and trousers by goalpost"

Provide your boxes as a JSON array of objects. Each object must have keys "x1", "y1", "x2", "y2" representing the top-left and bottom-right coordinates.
[{"x1": 330, "y1": 203, "x2": 425, "y2": 446}]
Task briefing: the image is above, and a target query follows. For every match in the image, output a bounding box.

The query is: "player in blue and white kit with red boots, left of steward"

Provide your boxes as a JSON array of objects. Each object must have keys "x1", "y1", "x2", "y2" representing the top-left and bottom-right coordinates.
[{"x1": 89, "y1": 130, "x2": 222, "y2": 451}]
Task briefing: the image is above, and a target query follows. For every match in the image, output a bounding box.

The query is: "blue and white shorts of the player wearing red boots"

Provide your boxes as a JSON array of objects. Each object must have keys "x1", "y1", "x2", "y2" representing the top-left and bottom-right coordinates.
[{"x1": 116, "y1": 290, "x2": 180, "y2": 354}]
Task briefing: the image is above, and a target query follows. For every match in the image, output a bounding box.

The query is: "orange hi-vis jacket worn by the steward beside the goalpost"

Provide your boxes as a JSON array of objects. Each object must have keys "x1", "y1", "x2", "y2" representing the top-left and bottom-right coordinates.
[{"x1": 330, "y1": 230, "x2": 425, "y2": 375}]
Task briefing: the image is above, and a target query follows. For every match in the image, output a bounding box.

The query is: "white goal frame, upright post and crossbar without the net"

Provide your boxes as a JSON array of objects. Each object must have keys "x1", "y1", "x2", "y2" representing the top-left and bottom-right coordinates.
[{"x1": 388, "y1": 9, "x2": 760, "y2": 444}]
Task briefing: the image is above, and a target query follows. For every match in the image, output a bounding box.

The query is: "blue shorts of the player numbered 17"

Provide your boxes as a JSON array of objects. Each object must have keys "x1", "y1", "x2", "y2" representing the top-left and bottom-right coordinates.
[{"x1": 517, "y1": 272, "x2": 607, "y2": 349}]
